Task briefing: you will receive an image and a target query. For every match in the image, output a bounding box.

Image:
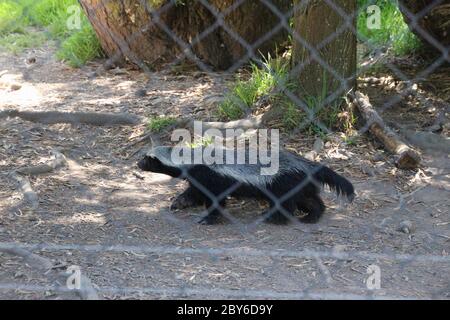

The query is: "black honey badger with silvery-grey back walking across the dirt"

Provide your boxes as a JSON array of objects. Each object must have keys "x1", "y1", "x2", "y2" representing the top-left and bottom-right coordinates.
[{"x1": 138, "y1": 147, "x2": 354, "y2": 224}]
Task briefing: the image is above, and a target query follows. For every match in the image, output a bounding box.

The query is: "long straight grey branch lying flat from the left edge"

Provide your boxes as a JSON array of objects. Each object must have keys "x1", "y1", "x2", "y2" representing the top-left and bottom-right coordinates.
[{"x1": 0, "y1": 109, "x2": 141, "y2": 126}]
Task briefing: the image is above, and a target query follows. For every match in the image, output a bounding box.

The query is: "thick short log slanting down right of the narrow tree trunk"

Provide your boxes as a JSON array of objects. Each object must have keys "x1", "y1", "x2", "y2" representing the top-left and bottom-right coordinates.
[{"x1": 354, "y1": 91, "x2": 420, "y2": 169}]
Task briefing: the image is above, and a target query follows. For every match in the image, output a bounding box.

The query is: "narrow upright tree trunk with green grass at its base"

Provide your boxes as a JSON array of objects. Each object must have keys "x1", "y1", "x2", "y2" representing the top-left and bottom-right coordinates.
[{"x1": 292, "y1": 0, "x2": 356, "y2": 99}]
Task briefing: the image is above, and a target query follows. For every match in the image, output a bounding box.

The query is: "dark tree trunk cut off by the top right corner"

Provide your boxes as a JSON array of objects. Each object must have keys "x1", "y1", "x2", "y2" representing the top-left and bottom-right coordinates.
[{"x1": 399, "y1": 0, "x2": 450, "y2": 51}]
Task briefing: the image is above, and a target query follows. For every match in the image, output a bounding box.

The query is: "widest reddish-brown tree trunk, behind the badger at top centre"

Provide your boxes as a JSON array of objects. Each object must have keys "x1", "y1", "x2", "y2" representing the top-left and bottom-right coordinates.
[{"x1": 79, "y1": 0, "x2": 291, "y2": 70}]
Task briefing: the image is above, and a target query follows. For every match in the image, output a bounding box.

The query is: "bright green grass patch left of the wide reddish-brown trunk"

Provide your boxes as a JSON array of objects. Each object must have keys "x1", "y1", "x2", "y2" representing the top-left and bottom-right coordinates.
[{"x1": 0, "y1": 0, "x2": 103, "y2": 67}]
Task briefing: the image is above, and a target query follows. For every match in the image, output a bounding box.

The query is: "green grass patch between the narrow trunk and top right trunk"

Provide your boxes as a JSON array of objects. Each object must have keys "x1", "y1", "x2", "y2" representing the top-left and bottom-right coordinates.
[{"x1": 357, "y1": 0, "x2": 422, "y2": 56}]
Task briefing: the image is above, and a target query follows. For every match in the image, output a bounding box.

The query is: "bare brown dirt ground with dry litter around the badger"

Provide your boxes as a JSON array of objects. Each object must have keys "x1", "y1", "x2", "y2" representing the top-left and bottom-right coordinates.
[{"x1": 0, "y1": 45, "x2": 450, "y2": 299}]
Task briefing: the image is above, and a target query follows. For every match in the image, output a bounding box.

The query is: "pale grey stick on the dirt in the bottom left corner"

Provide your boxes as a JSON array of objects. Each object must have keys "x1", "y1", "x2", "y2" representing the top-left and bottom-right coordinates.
[{"x1": 0, "y1": 248, "x2": 100, "y2": 300}]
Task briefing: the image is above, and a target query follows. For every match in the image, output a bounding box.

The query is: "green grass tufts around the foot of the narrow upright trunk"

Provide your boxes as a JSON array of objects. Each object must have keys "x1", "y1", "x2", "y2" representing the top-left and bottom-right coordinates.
[{"x1": 217, "y1": 53, "x2": 355, "y2": 134}]
